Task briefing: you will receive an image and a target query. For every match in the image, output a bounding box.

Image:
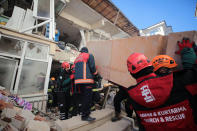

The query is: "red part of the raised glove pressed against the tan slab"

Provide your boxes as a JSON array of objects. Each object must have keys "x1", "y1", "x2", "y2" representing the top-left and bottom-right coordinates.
[{"x1": 175, "y1": 38, "x2": 195, "y2": 54}]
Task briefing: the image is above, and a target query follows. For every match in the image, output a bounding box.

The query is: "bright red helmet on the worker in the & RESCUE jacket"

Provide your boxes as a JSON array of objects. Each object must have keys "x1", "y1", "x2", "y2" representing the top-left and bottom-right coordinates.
[{"x1": 127, "y1": 53, "x2": 152, "y2": 74}]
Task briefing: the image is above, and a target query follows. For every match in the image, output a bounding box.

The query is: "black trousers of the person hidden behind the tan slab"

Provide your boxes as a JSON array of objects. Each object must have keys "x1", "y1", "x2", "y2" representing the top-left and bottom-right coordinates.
[{"x1": 114, "y1": 87, "x2": 133, "y2": 117}]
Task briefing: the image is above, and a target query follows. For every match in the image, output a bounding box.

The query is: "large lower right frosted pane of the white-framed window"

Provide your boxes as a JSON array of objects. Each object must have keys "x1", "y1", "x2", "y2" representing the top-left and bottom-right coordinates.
[{"x1": 18, "y1": 59, "x2": 47, "y2": 95}]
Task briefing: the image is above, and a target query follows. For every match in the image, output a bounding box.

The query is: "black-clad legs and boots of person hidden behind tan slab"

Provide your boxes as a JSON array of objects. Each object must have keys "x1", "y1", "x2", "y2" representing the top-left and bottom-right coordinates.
[{"x1": 111, "y1": 85, "x2": 133, "y2": 122}]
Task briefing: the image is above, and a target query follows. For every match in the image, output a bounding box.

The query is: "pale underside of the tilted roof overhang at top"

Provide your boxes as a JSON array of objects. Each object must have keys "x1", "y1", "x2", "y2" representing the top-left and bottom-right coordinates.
[{"x1": 60, "y1": 0, "x2": 136, "y2": 39}]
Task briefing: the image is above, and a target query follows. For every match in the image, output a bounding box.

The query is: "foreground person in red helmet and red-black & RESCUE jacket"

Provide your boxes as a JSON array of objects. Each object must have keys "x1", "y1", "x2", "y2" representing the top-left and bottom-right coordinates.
[{"x1": 127, "y1": 53, "x2": 197, "y2": 131}]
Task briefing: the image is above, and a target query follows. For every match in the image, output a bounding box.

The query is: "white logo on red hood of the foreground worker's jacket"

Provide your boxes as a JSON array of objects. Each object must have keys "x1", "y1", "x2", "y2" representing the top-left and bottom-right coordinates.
[{"x1": 140, "y1": 85, "x2": 155, "y2": 103}]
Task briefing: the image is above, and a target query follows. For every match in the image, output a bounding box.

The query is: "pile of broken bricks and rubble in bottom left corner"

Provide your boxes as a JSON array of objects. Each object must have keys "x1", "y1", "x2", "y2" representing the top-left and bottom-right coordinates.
[{"x1": 0, "y1": 90, "x2": 55, "y2": 131}]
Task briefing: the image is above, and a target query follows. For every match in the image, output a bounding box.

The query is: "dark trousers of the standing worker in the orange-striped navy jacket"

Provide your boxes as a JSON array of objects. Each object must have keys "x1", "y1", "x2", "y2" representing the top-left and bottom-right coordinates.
[{"x1": 77, "y1": 84, "x2": 93, "y2": 117}]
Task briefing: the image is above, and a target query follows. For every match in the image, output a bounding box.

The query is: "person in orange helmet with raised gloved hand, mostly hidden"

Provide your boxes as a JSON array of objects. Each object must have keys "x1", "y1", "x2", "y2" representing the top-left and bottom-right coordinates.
[{"x1": 152, "y1": 38, "x2": 197, "y2": 101}]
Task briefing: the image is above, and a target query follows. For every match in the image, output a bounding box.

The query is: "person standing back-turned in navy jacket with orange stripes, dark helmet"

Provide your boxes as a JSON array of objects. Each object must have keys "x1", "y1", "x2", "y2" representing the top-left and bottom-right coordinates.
[{"x1": 74, "y1": 47, "x2": 98, "y2": 122}]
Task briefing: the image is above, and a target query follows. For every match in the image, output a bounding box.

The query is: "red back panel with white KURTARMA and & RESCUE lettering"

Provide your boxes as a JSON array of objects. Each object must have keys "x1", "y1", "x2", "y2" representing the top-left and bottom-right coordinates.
[{"x1": 137, "y1": 100, "x2": 196, "y2": 131}]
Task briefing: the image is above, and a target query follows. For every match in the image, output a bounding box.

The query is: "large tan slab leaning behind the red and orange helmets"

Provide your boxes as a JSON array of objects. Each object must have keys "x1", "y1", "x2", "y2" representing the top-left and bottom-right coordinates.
[{"x1": 87, "y1": 31, "x2": 197, "y2": 87}]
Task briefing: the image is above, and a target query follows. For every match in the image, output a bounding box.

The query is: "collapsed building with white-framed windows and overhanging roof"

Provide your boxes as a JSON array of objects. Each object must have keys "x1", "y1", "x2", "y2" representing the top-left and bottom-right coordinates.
[{"x1": 0, "y1": 0, "x2": 138, "y2": 108}]
